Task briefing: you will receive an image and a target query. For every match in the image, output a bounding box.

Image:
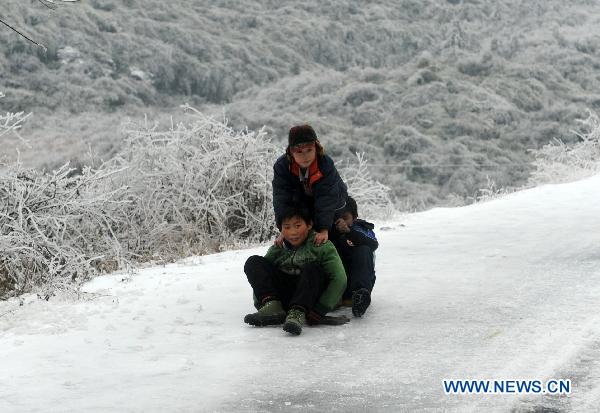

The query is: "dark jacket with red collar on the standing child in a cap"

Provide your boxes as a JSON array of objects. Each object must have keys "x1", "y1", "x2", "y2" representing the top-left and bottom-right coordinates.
[{"x1": 273, "y1": 155, "x2": 348, "y2": 231}]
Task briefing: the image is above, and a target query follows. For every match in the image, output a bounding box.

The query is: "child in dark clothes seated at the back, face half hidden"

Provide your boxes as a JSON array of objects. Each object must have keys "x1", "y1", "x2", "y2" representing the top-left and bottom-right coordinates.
[{"x1": 332, "y1": 196, "x2": 379, "y2": 317}]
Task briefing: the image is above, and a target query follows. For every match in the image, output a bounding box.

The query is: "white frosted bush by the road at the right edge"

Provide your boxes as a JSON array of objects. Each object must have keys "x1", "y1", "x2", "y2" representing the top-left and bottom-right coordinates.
[{"x1": 529, "y1": 112, "x2": 600, "y2": 185}]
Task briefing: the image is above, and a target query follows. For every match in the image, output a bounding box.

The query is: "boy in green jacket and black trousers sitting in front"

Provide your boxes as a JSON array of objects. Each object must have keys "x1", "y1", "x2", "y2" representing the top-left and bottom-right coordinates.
[{"x1": 244, "y1": 206, "x2": 348, "y2": 335}]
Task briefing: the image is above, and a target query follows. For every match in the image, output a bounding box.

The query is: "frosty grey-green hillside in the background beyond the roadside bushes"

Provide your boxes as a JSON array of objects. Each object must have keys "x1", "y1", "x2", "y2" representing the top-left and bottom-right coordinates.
[{"x1": 0, "y1": 0, "x2": 600, "y2": 206}]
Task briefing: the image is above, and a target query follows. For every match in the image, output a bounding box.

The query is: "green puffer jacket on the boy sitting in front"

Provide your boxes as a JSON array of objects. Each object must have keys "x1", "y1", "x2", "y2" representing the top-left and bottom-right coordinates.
[{"x1": 265, "y1": 231, "x2": 346, "y2": 315}]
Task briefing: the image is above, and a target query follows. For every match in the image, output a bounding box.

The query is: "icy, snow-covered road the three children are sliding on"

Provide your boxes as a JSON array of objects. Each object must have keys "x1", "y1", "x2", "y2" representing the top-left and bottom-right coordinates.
[{"x1": 0, "y1": 175, "x2": 600, "y2": 413}]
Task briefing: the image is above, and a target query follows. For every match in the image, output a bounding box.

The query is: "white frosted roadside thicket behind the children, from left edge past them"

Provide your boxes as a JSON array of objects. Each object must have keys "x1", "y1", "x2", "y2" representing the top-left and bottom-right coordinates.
[{"x1": 0, "y1": 103, "x2": 393, "y2": 298}]
